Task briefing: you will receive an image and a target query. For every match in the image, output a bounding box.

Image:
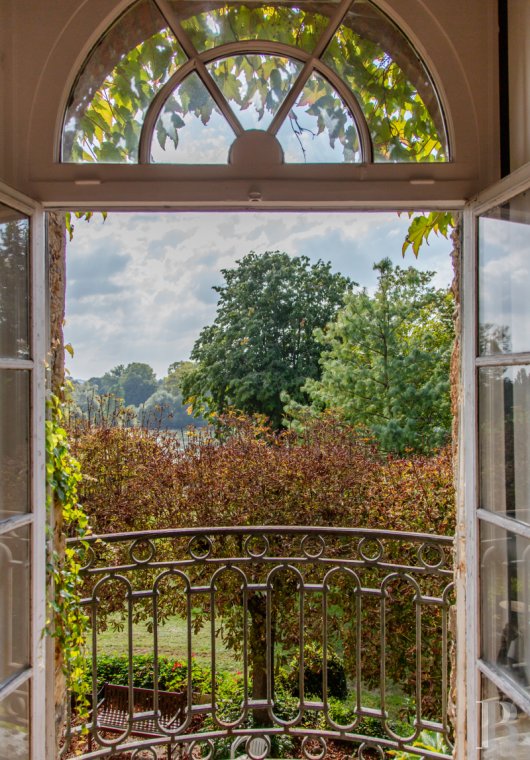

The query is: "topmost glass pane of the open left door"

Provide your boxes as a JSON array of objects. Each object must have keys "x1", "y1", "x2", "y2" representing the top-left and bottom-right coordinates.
[{"x1": 0, "y1": 203, "x2": 29, "y2": 359}]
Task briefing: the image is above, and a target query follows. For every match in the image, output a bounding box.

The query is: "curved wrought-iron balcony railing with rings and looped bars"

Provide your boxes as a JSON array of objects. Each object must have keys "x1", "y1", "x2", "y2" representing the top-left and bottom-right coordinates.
[{"x1": 60, "y1": 526, "x2": 453, "y2": 760}]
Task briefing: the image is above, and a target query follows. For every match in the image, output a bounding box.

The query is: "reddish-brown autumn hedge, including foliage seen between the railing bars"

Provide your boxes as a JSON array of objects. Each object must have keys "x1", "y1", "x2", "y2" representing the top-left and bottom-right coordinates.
[{"x1": 66, "y1": 416, "x2": 454, "y2": 715}]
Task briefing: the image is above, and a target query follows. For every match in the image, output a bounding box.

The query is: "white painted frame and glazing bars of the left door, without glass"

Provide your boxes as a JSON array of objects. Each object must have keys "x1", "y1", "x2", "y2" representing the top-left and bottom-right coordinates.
[{"x1": 0, "y1": 182, "x2": 48, "y2": 760}]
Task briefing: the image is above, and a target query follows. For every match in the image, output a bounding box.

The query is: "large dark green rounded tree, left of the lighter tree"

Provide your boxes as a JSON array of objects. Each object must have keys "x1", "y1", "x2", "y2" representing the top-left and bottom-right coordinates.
[{"x1": 182, "y1": 251, "x2": 351, "y2": 428}]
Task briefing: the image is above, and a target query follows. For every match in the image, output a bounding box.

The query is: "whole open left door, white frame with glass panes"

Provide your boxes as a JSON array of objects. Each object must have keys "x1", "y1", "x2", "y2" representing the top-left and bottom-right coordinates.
[{"x1": 0, "y1": 184, "x2": 47, "y2": 760}]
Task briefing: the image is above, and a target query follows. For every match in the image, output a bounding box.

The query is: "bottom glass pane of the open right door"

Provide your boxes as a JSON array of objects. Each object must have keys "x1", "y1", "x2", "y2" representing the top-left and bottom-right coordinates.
[{"x1": 481, "y1": 676, "x2": 530, "y2": 760}]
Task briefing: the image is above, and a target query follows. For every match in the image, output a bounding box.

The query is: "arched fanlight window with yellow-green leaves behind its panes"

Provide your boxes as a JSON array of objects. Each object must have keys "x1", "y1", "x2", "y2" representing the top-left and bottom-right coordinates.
[{"x1": 61, "y1": 0, "x2": 449, "y2": 164}]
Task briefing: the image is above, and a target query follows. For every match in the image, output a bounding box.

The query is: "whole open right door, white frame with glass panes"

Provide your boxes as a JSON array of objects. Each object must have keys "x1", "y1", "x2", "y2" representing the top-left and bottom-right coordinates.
[{"x1": 457, "y1": 166, "x2": 530, "y2": 760}]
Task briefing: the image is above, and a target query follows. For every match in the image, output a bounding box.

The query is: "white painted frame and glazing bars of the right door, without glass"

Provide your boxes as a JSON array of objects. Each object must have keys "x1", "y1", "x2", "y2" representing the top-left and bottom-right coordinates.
[{"x1": 457, "y1": 159, "x2": 530, "y2": 760}]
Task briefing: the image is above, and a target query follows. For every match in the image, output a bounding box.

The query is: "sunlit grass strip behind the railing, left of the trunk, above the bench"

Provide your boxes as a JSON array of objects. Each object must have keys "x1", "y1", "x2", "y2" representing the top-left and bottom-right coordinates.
[{"x1": 88, "y1": 617, "x2": 237, "y2": 673}]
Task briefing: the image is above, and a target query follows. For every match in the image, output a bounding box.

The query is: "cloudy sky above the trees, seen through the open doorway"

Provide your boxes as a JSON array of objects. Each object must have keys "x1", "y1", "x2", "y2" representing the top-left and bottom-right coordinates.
[{"x1": 65, "y1": 212, "x2": 452, "y2": 379}]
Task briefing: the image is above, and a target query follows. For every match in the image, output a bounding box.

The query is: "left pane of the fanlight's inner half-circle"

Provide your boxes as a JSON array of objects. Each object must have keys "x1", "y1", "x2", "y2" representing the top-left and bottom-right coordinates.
[{"x1": 151, "y1": 73, "x2": 234, "y2": 164}]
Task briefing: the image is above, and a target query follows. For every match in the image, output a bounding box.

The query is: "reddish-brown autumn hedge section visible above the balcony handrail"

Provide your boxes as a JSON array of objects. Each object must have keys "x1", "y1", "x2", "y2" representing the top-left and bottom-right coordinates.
[{"x1": 69, "y1": 416, "x2": 454, "y2": 535}]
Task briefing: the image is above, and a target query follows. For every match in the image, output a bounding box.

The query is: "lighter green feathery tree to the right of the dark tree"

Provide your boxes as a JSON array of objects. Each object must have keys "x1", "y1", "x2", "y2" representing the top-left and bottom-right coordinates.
[{"x1": 287, "y1": 259, "x2": 454, "y2": 453}]
